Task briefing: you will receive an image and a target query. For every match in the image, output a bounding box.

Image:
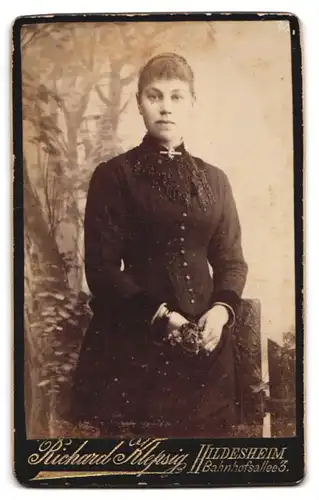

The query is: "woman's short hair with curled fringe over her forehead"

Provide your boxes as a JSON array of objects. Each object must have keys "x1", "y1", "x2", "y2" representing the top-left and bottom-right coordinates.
[{"x1": 138, "y1": 52, "x2": 195, "y2": 96}]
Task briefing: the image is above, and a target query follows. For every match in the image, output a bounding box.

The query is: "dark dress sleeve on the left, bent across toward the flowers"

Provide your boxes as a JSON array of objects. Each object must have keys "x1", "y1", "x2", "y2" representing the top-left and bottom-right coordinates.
[{"x1": 84, "y1": 160, "x2": 159, "y2": 326}]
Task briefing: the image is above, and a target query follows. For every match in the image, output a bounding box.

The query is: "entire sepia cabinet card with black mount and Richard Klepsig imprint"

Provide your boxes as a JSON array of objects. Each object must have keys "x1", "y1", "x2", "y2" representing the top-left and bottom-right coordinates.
[{"x1": 12, "y1": 12, "x2": 305, "y2": 488}]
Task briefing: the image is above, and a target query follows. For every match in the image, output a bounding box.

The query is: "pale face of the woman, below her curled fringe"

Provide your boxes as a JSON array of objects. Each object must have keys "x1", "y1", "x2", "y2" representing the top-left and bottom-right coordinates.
[{"x1": 138, "y1": 79, "x2": 194, "y2": 146}]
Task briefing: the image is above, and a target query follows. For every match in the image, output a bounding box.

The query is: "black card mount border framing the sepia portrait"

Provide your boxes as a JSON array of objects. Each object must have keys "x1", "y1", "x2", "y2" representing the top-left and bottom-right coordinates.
[{"x1": 12, "y1": 12, "x2": 305, "y2": 488}]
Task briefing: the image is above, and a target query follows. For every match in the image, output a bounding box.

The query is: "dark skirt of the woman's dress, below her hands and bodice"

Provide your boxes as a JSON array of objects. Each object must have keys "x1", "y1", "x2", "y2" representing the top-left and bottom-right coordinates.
[{"x1": 71, "y1": 315, "x2": 238, "y2": 437}]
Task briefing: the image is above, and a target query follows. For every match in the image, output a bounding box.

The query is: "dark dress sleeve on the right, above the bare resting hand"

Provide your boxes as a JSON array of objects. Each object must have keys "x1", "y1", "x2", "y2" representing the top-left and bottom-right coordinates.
[{"x1": 208, "y1": 174, "x2": 247, "y2": 312}]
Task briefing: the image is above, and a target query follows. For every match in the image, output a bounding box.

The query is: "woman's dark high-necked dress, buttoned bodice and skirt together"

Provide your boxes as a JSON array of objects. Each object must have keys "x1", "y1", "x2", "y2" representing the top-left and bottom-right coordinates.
[{"x1": 71, "y1": 134, "x2": 247, "y2": 437}]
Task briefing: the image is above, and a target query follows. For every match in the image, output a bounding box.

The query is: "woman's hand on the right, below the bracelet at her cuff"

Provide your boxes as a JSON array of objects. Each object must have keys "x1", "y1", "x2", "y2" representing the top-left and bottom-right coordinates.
[{"x1": 198, "y1": 305, "x2": 228, "y2": 352}]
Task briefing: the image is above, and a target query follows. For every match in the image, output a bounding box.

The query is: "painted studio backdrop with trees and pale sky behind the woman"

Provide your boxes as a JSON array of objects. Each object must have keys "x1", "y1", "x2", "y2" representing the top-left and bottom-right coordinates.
[{"x1": 21, "y1": 18, "x2": 295, "y2": 438}]
